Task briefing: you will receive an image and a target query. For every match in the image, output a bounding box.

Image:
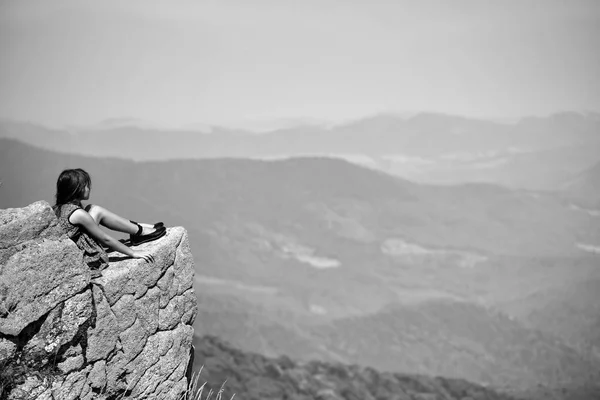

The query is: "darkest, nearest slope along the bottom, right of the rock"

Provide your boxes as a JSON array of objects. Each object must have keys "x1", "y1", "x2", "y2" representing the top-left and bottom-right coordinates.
[{"x1": 194, "y1": 336, "x2": 512, "y2": 400}]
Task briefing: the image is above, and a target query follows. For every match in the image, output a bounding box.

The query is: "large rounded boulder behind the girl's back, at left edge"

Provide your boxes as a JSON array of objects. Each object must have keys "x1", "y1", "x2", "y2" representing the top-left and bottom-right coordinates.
[{"x1": 0, "y1": 202, "x2": 90, "y2": 336}]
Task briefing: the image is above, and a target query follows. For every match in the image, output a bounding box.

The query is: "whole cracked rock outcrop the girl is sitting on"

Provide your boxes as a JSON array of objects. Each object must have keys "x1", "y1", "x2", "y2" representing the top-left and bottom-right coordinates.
[{"x1": 0, "y1": 202, "x2": 197, "y2": 400}]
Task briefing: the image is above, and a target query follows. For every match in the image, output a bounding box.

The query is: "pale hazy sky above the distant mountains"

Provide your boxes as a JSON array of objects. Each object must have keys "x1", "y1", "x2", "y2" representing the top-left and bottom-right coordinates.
[{"x1": 0, "y1": 0, "x2": 600, "y2": 125}]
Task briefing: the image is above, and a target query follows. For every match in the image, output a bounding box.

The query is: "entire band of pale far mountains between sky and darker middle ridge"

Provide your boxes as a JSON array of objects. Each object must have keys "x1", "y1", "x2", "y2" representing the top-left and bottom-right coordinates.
[{"x1": 0, "y1": 113, "x2": 600, "y2": 189}]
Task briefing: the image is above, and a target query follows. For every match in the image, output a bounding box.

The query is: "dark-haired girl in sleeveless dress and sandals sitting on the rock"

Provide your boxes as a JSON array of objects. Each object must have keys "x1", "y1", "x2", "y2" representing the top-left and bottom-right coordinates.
[{"x1": 52, "y1": 168, "x2": 166, "y2": 278}]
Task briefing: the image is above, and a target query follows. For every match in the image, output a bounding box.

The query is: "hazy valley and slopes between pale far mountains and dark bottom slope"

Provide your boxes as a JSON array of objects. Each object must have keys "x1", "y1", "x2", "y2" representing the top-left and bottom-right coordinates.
[{"x1": 0, "y1": 135, "x2": 600, "y2": 398}]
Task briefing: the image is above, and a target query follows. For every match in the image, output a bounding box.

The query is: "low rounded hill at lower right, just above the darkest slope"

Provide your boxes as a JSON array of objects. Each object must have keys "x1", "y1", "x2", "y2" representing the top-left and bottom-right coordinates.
[{"x1": 316, "y1": 301, "x2": 600, "y2": 389}]
